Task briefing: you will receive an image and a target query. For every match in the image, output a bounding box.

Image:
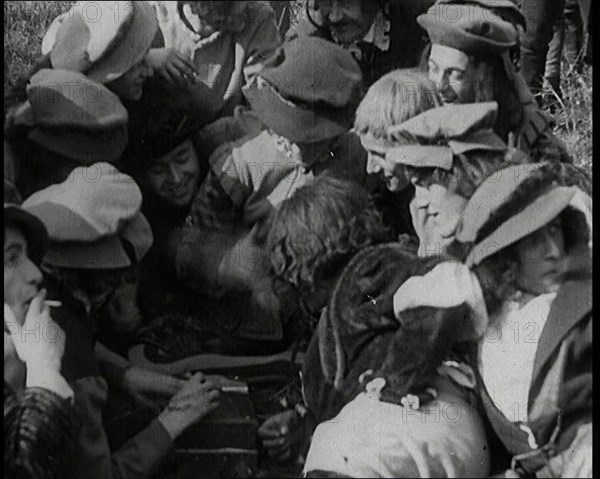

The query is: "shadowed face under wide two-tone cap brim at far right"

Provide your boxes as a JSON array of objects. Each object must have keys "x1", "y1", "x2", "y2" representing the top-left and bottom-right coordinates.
[{"x1": 516, "y1": 217, "x2": 565, "y2": 294}]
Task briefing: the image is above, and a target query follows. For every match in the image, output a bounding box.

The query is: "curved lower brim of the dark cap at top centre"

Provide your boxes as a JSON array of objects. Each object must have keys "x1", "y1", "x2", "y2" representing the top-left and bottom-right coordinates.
[{"x1": 243, "y1": 81, "x2": 353, "y2": 143}]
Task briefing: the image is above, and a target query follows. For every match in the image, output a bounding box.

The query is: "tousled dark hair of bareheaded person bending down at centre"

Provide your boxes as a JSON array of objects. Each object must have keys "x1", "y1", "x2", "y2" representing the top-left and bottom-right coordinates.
[{"x1": 267, "y1": 175, "x2": 390, "y2": 302}]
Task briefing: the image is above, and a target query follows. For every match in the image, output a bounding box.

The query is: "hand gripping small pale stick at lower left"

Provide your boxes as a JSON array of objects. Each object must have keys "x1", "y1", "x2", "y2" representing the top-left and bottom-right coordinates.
[{"x1": 158, "y1": 373, "x2": 221, "y2": 439}]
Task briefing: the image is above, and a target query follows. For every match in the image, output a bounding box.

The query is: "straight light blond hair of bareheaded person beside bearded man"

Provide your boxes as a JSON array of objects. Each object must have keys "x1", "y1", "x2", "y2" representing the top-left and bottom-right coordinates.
[{"x1": 354, "y1": 68, "x2": 442, "y2": 141}]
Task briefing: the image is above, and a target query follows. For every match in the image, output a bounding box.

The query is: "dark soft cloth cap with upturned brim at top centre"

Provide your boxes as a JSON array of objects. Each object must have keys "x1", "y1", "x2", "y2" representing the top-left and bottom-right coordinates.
[{"x1": 244, "y1": 37, "x2": 363, "y2": 142}]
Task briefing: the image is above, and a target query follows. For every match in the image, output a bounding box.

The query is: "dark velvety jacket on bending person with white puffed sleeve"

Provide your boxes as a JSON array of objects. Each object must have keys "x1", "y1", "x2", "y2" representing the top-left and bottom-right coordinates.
[{"x1": 303, "y1": 243, "x2": 468, "y2": 422}]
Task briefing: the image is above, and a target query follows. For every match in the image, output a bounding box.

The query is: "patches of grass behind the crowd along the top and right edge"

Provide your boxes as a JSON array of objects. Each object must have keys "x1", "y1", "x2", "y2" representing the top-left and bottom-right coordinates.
[{"x1": 4, "y1": 0, "x2": 593, "y2": 176}]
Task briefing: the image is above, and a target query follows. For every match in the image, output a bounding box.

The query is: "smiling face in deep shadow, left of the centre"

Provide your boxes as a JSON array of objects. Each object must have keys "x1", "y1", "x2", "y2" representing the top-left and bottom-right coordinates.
[{"x1": 145, "y1": 140, "x2": 200, "y2": 207}]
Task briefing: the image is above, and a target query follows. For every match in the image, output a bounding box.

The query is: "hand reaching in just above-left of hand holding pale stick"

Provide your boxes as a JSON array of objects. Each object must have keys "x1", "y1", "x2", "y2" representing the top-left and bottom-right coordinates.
[{"x1": 123, "y1": 366, "x2": 186, "y2": 407}]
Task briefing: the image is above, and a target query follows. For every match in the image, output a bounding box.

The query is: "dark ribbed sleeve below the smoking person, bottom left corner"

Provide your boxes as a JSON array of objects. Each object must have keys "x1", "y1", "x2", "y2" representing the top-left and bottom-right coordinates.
[{"x1": 4, "y1": 383, "x2": 78, "y2": 479}]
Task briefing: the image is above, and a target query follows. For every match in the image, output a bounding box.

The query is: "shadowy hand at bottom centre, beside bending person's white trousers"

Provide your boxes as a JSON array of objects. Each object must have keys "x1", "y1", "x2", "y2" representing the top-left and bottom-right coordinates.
[{"x1": 258, "y1": 409, "x2": 304, "y2": 462}]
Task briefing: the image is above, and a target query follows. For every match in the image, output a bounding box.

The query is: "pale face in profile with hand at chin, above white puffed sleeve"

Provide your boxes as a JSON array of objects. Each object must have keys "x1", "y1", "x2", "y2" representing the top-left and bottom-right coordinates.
[{"x1": 410, "y1": 184, "x2": 467, "y2": 256}]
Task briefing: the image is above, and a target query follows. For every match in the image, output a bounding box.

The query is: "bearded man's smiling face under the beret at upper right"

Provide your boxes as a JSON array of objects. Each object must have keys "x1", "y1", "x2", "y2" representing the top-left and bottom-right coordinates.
[{"x1": 428, "y1": 44, "x2": 492, "y2": 103}]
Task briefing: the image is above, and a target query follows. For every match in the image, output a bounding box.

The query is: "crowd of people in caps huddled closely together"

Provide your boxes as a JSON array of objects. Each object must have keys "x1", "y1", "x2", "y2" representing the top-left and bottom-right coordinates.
[{"x1": 4, "y1": 0, "x2": 592, "y2": 479}]
